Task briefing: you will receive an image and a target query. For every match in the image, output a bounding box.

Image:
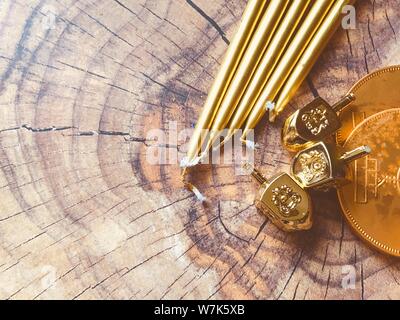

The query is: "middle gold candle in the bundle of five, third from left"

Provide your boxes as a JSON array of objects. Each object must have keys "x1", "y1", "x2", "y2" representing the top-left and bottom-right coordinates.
[{"x1": 224, "y1": 0, "x2": 311, "y2": 145}]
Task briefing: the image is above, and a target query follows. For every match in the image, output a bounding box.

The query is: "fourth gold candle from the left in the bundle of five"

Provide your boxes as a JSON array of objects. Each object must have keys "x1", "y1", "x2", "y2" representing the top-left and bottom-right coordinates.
[{"x1": 242, "y1": 0, "x2": 336, "y2": 140}]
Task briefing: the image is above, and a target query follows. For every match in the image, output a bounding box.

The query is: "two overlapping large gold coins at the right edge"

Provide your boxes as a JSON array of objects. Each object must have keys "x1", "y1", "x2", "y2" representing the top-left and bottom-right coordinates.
[{"x1": 336, "y1": 66, "x2": 400, "y2": 256}]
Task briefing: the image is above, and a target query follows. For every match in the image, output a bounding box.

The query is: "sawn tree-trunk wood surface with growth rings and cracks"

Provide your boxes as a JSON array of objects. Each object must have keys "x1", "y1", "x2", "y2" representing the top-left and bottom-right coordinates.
[{"x1": 0, "y1": 0, "x2": 400, "y2": 299}]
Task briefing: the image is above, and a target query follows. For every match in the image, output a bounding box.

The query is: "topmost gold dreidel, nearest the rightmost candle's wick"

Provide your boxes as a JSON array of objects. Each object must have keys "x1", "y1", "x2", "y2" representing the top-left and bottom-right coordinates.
[{"x1": 282, "y1": 93, "x2": 355, "y2": 151}]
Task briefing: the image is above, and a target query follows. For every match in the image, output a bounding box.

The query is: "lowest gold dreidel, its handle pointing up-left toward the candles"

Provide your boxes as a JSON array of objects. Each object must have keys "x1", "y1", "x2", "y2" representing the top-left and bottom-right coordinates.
[{"x1": 244, "y1": 164, "x2": 312, "y2": 232}]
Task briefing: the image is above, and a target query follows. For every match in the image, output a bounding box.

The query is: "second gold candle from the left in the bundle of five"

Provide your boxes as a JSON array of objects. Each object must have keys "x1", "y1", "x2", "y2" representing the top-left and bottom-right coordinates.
[{"x1": 204, "y1": 0, "x2": 289, "y2": 151}]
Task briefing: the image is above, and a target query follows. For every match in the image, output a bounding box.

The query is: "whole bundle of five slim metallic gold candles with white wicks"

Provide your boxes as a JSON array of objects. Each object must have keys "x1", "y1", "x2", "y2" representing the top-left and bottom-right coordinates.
[{"x1": 181, "y1": 0, "x2": 354, "y2": 180}]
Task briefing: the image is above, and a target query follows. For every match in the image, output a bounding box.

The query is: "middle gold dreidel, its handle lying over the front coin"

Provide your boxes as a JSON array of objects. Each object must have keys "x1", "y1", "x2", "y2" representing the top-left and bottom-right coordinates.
[{"x1": 291, "y1": 141, "x2": 371, "y2": 189}]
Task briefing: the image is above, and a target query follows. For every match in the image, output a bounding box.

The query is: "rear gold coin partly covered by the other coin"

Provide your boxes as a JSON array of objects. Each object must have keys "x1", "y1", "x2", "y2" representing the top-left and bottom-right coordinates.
[{"x1": 336, "y1": 66, "x2": 400, "y2": 145}]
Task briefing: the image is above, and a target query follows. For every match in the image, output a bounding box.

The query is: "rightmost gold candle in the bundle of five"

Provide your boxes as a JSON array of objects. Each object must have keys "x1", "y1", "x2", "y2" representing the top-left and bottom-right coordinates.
[{"x1": 269, "y1": 0, "x2": 354, "y2": 121}]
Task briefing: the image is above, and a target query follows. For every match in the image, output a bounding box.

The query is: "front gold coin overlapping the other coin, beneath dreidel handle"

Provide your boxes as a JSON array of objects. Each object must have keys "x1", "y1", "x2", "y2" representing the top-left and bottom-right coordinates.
[{"x1": 338, "y1": 108, "x2": 400, "y2": 256}]
